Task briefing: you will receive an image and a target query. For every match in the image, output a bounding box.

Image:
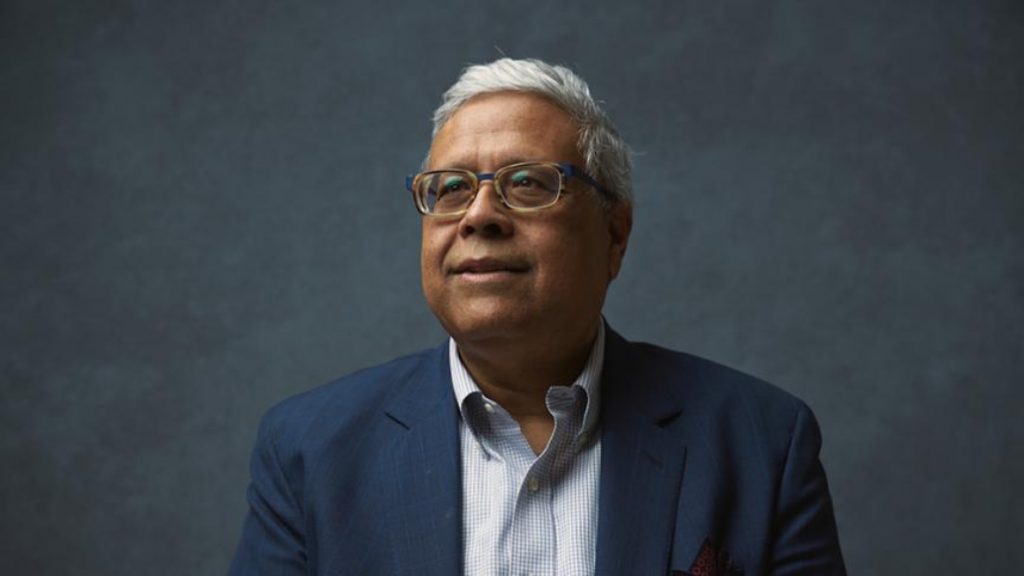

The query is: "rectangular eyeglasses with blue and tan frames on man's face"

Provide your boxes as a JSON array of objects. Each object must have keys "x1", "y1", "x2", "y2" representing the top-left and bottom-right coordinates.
[{"x1": 406, "y1": 162, "x2": 608, "y2": 216}]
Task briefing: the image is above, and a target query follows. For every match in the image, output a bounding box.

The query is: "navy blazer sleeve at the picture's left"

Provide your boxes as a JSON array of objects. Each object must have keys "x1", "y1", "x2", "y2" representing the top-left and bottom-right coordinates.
[{"x1": 228, "y1": 412, "x2": 307, "y2": 576}]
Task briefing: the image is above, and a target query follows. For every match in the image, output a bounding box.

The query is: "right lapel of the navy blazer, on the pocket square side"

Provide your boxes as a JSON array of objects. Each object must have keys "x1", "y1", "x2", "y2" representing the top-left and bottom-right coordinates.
[{"x1": 596, "y1": 329, "x2": 687, "y2": 576}]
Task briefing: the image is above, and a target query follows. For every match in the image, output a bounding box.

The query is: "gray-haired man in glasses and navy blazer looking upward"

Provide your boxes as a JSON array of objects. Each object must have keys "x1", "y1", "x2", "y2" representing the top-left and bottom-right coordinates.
[{"x1": 231, "y1": 58, "x2": 845, "y2": 576}]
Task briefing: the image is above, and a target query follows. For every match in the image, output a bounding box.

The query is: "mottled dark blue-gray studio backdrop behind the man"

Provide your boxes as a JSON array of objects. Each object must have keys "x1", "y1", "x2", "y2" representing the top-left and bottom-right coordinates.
[{"x1": 0, "y1": 0, "x2": 1024, "y2": 575}]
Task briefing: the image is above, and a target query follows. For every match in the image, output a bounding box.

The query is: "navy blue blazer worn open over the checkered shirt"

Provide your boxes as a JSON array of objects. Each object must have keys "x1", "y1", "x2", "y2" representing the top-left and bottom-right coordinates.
[{"x1": 230, "y1": 330, "x2": 845, "y2": 576}]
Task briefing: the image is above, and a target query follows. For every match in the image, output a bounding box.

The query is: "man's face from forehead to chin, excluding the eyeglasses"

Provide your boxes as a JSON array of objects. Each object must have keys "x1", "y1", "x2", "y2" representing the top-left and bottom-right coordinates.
[{"x1": 421, "y1": 92, "x2": 631, "y2": 344}]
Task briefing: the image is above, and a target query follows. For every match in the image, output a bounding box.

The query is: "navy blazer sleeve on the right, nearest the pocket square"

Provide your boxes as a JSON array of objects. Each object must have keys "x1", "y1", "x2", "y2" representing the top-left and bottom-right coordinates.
[{"x1": 770, "y1": 403, "x2": 846, "y2": 576}]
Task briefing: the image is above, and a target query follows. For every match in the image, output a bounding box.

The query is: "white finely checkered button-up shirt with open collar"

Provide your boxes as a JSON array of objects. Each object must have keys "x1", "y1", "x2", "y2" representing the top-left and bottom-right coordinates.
[{"x1": 449, "y1": 323, "x2": 604, "y2": 576}]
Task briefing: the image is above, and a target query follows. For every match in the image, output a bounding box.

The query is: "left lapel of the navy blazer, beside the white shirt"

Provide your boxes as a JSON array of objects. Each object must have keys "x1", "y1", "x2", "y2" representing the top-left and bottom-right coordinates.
[{"x1": 380, "y1": 343, "x2": 463, "y2": 576}]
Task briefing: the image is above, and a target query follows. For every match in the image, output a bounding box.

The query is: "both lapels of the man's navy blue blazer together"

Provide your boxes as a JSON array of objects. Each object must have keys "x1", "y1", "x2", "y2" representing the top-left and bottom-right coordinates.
[{"x1": 368, "y1": 326, "x2": 696, "y2": 576}]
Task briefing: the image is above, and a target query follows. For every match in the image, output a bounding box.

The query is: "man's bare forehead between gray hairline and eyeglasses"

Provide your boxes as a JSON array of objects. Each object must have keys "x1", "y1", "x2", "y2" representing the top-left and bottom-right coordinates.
[{"x1": 430, "y1": 92, "x2": 582, "y2": 171}]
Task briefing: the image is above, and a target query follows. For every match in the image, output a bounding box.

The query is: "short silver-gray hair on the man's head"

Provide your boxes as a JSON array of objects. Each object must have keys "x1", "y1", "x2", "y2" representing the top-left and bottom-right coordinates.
[{"x1": 425, "y1": 58, "x2": 633, "y2": 204}]
